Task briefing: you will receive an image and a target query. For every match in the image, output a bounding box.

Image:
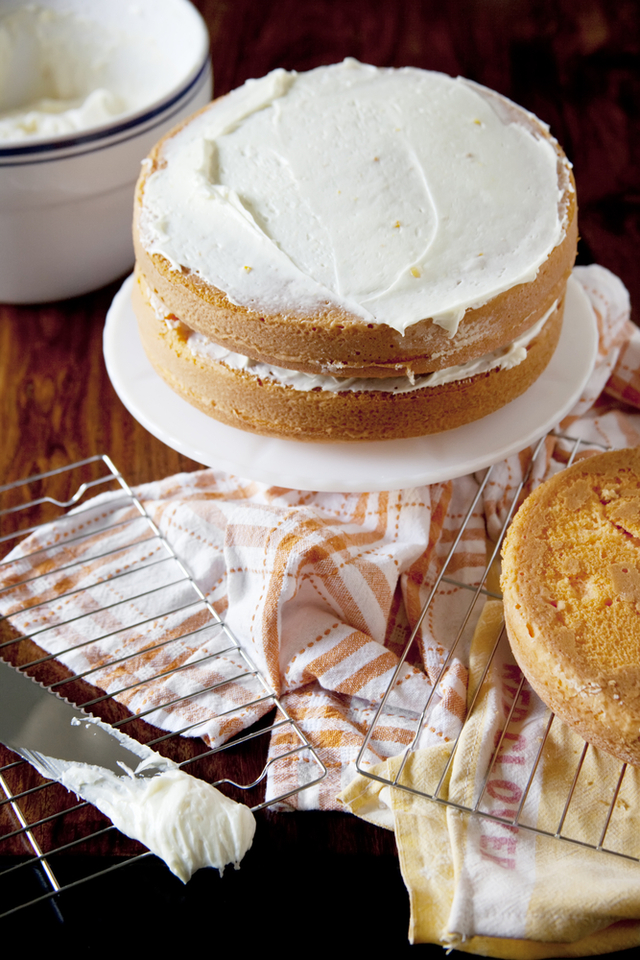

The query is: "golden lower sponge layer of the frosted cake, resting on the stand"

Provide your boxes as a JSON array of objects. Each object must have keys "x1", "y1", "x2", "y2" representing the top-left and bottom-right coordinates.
[{"x1": 133, "y1": 277, "x2": 564, "y2": 443}]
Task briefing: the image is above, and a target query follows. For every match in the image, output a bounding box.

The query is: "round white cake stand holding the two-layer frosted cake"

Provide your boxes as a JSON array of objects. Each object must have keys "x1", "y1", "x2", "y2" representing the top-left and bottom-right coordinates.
[{"x1": 104, "y1": 277, "x2": 598, "y2": 492}]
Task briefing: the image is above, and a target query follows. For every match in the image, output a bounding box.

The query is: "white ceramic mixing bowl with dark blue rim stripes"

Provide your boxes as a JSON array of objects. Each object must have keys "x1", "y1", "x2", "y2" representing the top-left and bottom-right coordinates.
[{"x1": 0, "y1": 0, "x2": 212, "y2": 303}]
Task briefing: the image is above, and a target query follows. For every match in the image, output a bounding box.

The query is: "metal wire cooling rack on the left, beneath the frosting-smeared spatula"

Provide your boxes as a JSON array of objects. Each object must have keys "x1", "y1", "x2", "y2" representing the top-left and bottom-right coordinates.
[{"x1": 0, "y1": 456, "x2": 326, "y2": 917}]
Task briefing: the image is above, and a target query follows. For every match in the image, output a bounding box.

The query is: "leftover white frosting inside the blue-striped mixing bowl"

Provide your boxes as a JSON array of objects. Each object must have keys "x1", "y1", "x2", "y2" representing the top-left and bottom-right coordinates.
[{"x1": 0, "y1": 4, "x2": 174, "y2": 144}]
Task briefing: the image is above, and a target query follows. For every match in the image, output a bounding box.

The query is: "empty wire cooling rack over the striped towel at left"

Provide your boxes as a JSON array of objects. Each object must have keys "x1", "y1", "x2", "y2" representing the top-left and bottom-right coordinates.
[{"x1": 0, "y1": 456, "x2": 326, "y2": 918}]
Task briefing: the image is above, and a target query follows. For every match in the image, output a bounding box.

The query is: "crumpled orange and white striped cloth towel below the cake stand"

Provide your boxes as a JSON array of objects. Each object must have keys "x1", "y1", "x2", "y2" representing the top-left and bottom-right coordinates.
[{"x1": 0, "y1": 258, "x2": 640, "y2": 809}]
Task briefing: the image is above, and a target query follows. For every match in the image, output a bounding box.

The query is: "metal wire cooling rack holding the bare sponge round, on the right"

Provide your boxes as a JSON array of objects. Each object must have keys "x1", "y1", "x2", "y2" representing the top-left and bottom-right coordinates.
[{"x1": 356, "y1": 434, "x2": 640, "y2": 861}]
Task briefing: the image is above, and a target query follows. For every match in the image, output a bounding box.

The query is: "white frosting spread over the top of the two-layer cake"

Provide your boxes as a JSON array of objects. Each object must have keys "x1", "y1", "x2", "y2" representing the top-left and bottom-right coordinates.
[{"x1": 140, "y1": 60, "x2": 568, "y2": 336}]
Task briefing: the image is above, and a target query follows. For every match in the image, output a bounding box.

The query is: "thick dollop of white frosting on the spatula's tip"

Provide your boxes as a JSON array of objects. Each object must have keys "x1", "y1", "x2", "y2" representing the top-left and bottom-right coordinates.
[{"x1": 59, "y1": 761, "x2": 256, "y2": 883}]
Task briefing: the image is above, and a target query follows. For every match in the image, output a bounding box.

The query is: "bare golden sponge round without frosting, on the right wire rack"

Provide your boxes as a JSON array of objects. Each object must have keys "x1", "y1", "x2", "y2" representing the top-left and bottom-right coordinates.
[{"x1": 502, "y1": 448, "x2": 640, "y2": 764}]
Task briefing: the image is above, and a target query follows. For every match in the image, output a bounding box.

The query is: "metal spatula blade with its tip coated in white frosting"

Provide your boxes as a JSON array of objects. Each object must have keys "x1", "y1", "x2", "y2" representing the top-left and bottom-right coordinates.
[{"x1": 0, "y1": 659, "x2": 255, "y2": 883}]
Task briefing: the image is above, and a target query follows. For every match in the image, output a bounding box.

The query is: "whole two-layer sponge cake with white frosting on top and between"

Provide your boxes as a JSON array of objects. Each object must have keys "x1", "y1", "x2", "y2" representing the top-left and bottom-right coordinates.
[{"x1": 134, "y1": 60, "x2": 577, "y2": 440}]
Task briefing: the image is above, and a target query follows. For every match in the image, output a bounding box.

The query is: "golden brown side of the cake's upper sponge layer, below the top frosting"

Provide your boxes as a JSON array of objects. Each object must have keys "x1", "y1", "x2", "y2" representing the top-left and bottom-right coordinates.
[{"x1": 133, "y1": 95, "x2": 578, "y2": 377}]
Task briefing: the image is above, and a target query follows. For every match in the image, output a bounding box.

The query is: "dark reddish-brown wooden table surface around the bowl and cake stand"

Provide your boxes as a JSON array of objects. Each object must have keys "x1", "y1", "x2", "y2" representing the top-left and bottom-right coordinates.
[{"x1": 0, "y1": 0, "x2": 640, "y2": 944}]
